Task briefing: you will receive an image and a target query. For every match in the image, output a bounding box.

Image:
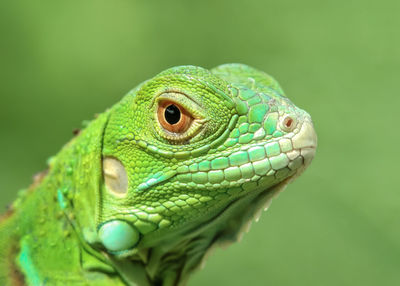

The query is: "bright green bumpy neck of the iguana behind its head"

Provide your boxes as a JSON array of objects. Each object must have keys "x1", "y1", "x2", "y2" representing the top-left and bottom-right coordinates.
[{"x1": 0, "y1": 112, "x2": 122, "y2": 285}]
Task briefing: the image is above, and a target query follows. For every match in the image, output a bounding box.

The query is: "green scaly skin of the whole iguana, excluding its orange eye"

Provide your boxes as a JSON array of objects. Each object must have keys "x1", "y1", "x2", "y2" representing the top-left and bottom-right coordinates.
[{"x1": 0, "y1": 64, "x2": 316, "y2": 286}]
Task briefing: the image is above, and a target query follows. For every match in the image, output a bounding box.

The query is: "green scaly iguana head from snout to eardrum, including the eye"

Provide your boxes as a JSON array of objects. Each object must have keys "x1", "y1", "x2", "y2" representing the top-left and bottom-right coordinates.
[{"x1": 94, "y1": 64, "x2": 316, "y2": 282}]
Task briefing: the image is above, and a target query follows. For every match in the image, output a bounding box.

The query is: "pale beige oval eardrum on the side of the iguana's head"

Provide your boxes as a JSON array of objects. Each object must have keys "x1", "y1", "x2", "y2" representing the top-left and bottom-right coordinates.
[{"x1": 103, "y1": 157, "x2": 128, "y2": 196}]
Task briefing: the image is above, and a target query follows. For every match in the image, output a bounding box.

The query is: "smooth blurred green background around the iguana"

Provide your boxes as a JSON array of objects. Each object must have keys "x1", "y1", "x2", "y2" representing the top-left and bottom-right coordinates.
[{"x1": 0, "y1": 0, "x2": 400, "y2": 286}]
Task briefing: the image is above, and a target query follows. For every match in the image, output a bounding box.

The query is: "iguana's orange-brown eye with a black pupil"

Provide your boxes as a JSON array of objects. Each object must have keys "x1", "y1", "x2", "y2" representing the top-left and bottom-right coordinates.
[{"x1": 157, "y1": 101, "x2": 193, "y2": 133}]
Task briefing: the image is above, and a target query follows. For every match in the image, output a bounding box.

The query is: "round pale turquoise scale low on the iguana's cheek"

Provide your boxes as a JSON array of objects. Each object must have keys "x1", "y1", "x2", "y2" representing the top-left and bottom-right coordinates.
[{"x1": 99, "y1": 220, "x2": 140, "y2": 252}]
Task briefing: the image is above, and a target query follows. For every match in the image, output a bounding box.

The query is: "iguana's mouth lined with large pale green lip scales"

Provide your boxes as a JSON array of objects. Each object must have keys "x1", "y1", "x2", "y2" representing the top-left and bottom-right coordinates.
[{"x1": 167, "y1": 118, "x2": 317, "y2": 189}]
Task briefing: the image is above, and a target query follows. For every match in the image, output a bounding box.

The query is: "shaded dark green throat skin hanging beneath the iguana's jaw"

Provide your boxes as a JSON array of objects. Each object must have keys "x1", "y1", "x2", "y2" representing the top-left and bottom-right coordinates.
[{"x1": 107, "y1": 180, "x2": 289, "y2": 286}]
